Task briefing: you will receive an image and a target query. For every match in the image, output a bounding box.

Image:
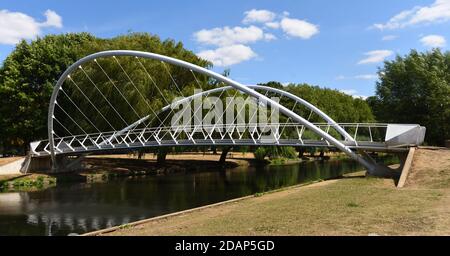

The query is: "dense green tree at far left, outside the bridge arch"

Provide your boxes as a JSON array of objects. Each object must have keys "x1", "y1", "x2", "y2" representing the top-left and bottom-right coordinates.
[{"x1": 0, "y1": 33, "x2": 94, "y2": 153}]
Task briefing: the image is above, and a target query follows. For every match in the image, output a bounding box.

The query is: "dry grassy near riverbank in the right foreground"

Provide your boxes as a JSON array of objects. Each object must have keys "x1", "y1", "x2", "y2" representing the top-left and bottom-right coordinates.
[{"x1": 90, "y1": 148, "x2": 450, "y2": 235}]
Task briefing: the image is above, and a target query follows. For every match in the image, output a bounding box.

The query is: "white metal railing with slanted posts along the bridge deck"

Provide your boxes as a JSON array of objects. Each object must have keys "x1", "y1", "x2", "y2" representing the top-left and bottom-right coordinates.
[{"x1": 31, "y1": 122, "x2": 394, "y2": 156}]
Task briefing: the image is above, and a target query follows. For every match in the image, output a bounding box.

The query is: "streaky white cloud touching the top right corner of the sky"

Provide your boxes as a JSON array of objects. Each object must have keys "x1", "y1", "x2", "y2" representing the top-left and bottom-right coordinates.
[{"x1": 373, "y1": 0, "x2": 450, "y2": 30}]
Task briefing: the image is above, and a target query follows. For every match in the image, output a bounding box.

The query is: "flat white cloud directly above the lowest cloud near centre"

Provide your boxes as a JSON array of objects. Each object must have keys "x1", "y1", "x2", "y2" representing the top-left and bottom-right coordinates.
[{"x1": 194, "y1": 26, "x2": 264, "y2": 46}]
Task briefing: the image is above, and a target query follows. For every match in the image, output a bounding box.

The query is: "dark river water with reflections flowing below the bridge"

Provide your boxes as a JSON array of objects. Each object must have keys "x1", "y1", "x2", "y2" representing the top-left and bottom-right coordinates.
[{"x1": 0, "y1": 160, "x2": 361, "y2": 235}]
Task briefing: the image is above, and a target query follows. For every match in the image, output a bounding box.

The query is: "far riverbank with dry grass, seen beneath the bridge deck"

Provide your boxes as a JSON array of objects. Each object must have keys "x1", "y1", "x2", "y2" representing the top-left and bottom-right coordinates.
[{"x1": 0, "y1": 152, "x2": 332, "y2": 192}]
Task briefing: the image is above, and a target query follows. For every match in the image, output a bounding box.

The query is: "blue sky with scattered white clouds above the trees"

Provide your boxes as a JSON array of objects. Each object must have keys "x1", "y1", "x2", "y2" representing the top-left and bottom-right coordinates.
[{"x1": 0, "y1": 0, "x2": 450, "y2": 97}]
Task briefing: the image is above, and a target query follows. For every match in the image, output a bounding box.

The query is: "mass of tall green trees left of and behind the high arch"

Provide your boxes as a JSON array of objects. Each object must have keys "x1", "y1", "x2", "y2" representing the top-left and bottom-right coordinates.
[{"x1": 0, "y1": 33, "x2": 211, "y2": 153}]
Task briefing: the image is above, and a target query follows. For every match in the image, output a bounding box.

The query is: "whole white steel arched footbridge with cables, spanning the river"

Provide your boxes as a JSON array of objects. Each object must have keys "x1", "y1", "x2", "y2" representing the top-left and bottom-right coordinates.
[{"x1": 24, "y1": 50, "x2": 425, "y2": 175}]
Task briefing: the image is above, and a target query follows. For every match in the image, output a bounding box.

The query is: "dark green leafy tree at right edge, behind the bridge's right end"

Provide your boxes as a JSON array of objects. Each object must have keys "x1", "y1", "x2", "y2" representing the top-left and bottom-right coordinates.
[{"x1": 367, "y1": 49, "x2": 450, "y2": 145}]
